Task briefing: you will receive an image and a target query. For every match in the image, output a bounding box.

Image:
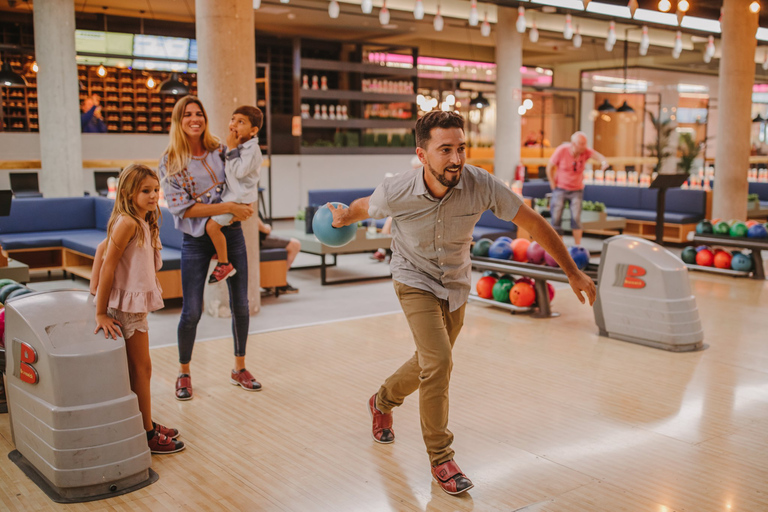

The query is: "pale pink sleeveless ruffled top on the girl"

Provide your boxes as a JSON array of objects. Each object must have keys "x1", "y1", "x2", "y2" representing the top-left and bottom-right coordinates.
[{"x1": 107, "y1": 219, "x2": 163, "y2": 313}]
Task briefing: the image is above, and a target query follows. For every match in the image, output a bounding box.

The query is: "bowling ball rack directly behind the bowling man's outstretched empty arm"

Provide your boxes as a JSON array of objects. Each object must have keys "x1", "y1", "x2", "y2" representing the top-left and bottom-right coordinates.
[{"x1": 469, "y1": 256, "x2": 600, "y2": 318}]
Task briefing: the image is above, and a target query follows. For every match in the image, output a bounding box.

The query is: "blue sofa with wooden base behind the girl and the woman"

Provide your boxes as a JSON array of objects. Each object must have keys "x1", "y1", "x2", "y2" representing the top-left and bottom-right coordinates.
[{"x1": 0, "y1": 197, "x2": 287, "y2": 298}]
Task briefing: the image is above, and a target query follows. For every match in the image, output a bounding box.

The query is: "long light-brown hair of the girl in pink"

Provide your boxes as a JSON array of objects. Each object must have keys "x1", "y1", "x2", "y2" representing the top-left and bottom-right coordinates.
[{"x1": 107, "y1": 164, "x2": 161, "y2": 249}]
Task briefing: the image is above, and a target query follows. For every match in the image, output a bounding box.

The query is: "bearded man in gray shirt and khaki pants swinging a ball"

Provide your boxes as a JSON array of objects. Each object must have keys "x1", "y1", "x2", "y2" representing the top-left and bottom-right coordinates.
[{"x1": 328, "y1": 111, "x2": 596, "y2": 494}]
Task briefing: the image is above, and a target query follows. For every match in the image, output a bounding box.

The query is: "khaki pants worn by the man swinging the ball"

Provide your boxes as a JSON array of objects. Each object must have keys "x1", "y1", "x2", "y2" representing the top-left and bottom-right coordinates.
[{"x1": 376, "y1": 281, "x2": 466, "y2": 466}]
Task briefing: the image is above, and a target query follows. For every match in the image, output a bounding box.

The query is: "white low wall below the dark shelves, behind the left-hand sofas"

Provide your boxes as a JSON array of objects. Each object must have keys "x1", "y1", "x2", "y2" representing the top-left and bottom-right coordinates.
[{"x1": 0, "y1": 132, "x2": 416, "y2": 217}]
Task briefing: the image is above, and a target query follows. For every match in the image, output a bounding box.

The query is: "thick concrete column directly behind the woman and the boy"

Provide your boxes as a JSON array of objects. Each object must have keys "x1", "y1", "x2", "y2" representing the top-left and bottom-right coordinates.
[{"x1": 195, "y1": 0, "x2": 261, "y2": 314}]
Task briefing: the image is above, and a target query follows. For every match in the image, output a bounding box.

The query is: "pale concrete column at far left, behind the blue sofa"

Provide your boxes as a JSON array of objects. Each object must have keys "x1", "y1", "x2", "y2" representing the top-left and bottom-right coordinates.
[{"x1": 34, "y1": 0, "x2": 84, "y2": 197}]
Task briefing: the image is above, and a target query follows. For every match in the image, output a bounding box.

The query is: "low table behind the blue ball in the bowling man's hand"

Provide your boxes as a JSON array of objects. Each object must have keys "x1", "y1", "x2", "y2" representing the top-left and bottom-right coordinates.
[{"x1": 273, "y1": 228, "x2": 392, "y2": 286}]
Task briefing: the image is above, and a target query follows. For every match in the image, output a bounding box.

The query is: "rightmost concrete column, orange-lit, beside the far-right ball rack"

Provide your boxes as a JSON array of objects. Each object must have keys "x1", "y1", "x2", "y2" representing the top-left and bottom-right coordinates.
[{"x1": 712, "y1": 0, "x2": 757, "y2": 220}]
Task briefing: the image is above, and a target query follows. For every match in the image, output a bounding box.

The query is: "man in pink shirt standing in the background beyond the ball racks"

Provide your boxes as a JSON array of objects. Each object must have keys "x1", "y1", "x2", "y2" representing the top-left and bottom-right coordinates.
[{"x1": 547, "y1": 132, "x2": 608, "y2": 245}]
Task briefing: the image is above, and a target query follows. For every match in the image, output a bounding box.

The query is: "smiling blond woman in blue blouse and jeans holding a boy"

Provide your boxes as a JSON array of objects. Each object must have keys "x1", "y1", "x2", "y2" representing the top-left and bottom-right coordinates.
[{"x1": 159, "y1": 96, "x2": 261, "y2": 400}]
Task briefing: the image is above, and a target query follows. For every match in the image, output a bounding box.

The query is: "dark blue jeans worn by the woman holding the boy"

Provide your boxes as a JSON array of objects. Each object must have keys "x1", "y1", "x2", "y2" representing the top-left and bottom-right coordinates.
[{"x1": 178, "y1": 222, "x2": 250, "y2": 364}]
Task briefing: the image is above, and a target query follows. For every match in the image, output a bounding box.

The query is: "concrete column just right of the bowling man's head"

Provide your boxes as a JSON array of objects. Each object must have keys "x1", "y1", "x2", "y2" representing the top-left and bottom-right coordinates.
[{"x1": 493, "y1": 6, "x2": 523, "y2": 183}]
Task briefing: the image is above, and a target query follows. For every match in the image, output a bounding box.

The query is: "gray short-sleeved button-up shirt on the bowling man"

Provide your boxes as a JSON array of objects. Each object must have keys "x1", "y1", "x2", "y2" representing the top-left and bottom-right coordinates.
[{"x1": 368, "y1": 165, "x2": 523, "y2": 311}]
